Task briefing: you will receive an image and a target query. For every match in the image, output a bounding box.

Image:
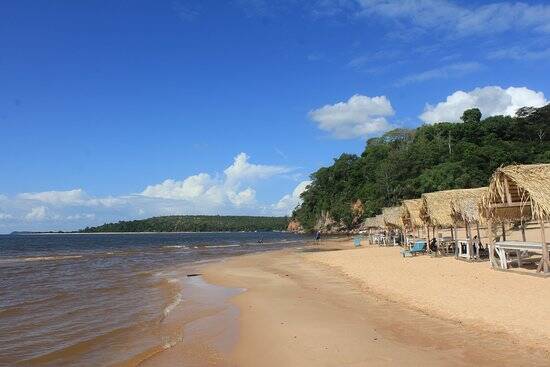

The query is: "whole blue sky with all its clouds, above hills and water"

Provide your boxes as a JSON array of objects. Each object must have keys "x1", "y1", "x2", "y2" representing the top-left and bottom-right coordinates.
[{"x1": 0, "y1": 0, "x2": 550, "y2": 233}]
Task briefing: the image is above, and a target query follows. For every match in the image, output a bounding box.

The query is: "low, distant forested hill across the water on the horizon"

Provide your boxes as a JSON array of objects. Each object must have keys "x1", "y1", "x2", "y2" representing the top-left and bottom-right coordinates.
[{"x1": 79, "y1": 215, "x2": 294, "y2": 233}]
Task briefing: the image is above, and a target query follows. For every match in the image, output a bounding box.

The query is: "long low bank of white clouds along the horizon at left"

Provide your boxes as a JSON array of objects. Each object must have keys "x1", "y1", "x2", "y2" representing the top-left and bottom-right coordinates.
[{"x1": 0, "y1": 153, "x2": 298, "y2": 231}]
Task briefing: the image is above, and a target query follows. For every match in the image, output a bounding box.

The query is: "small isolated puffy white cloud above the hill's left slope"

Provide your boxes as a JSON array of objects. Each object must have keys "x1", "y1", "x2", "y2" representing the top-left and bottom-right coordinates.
[{"x1": 309, "y1": 94, "x2": 395, "y2": 139}]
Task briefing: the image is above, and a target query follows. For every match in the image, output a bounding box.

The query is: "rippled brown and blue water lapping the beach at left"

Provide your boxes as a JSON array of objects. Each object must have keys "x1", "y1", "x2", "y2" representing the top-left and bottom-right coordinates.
[{"x1": 0, "y1": 232, "x2": 308, "y2": 366}]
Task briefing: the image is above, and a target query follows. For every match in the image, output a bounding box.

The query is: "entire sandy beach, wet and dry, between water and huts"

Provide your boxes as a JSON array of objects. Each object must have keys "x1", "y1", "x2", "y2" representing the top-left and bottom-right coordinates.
[{"x1": 145, "y1": 240, "x2": 550, "y2": 366}]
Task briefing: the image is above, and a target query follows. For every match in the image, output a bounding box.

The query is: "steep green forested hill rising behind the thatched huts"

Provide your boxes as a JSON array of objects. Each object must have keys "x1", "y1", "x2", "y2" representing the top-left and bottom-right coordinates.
[{"x1": 293, "y1": 105, "x2": 550, "y2": 230}]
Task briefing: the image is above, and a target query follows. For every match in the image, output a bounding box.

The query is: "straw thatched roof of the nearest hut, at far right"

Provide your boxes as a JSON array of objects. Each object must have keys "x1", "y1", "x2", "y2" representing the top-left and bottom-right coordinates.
[{"x1": 480, "y1": 164, "x2": 550, "y2": 221}]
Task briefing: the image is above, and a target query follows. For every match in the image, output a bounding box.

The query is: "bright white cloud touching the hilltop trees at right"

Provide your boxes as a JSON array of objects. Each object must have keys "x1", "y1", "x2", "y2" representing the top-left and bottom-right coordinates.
[{"x1": 420, "y1": 86, "x2": 548, "y2": 123}]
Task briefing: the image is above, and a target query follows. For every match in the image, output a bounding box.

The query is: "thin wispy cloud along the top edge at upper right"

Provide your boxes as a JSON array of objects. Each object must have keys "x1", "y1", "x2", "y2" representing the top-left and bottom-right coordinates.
[{"x1": 358, "y1": 0, "x2": 550, "y2": 36}]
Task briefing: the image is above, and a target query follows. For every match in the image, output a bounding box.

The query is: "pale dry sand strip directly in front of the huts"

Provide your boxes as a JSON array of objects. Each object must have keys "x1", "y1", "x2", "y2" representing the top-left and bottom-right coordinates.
[{"x1": 307, "y1": 243, "x2": 550, "y2": 348}]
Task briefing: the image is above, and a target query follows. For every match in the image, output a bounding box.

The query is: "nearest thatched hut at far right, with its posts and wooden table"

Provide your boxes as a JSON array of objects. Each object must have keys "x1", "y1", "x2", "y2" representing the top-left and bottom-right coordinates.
[{"x1": 479, "y1": 164, "x2": 550, "y2": 275}]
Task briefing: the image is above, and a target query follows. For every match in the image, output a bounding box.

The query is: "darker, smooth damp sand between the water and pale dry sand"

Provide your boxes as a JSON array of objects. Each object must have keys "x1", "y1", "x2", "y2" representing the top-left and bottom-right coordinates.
[{"x1": 146, "y1": 241, "x2": 550, "y2": 367}]
